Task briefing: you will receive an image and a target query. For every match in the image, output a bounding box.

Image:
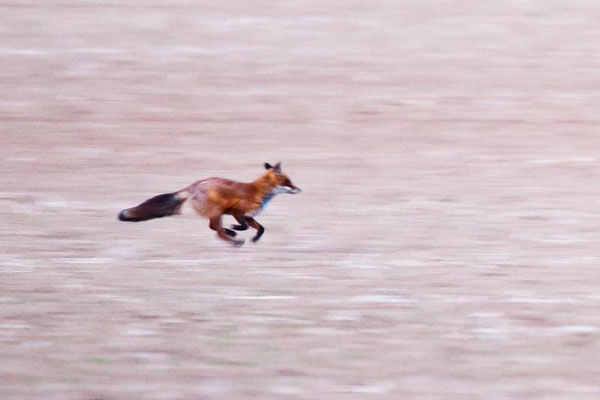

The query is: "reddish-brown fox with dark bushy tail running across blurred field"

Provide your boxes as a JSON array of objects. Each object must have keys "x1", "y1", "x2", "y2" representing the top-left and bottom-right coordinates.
[{"x1": 119, "y1": 163, "x2": 300, "y2": 246}]
